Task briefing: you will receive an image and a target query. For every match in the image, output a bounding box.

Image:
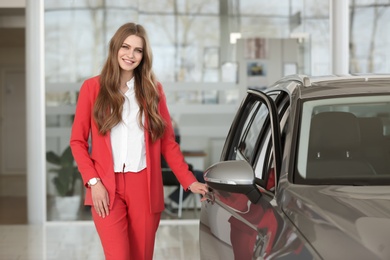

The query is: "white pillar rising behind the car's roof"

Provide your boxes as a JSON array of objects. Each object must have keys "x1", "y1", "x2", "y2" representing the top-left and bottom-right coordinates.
[{"x1": 329, "y1": 0, "x2": 349, "y2": 75}]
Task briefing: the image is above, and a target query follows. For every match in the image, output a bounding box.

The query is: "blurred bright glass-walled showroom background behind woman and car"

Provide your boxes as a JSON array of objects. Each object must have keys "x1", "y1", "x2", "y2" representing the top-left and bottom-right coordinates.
[{"x1": 0, "y1": 0, "x2": 390, "y2": 224}]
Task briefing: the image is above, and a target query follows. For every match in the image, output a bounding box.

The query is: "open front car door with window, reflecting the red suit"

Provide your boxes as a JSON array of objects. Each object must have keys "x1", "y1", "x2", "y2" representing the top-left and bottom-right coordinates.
[{"x1": 200, "y1": 90, "x2": 281, "y2": 259}]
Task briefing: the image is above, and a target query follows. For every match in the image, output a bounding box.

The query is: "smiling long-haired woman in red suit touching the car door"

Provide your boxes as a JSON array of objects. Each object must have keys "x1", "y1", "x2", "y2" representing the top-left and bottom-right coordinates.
[{"x1": 70, "y1": 23, "x2": 207, "y2": 260}]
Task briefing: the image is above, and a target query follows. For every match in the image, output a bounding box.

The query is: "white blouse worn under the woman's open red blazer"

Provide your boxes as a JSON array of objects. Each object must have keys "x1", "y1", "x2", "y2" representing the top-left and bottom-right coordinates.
[{"x1": 111, "y1": 78, "x2": 146, "y2": 172}]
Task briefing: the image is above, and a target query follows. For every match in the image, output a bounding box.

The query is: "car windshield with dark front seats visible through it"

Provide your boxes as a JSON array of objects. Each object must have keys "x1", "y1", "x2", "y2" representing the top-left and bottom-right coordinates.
[{"x1": 297, "y1": 95, "x2": 390, "y2": 185}]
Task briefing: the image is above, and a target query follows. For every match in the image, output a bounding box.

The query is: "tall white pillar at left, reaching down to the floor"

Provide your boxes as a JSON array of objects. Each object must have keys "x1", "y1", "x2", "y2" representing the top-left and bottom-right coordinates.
[{"x1": 26, "y1": 0, "x2": 46, "y2": 224}]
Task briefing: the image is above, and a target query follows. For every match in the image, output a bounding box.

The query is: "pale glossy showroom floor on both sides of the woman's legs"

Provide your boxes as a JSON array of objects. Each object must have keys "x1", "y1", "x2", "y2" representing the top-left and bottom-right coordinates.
[{"x1": 0, "y1": 178, "x2": 199, "y2": 260}]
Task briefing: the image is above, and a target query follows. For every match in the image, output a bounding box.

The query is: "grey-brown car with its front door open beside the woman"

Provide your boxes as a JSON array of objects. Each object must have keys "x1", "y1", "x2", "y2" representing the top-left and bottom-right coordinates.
[{"x1": 199, "y1": 74, "x2": 390, "y2": 260}]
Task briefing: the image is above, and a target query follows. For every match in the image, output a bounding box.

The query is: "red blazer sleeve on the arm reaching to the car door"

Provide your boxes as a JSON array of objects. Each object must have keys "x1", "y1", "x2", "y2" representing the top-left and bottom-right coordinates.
[{"x1": 159, "y1": 84, "x2": 197, "y2": 190}]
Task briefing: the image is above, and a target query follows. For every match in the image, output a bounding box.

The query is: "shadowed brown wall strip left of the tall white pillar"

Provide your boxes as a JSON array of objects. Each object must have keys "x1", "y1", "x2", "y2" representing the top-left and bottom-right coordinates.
[{"x1": 0, "y1": 5, "x2": 27, "y2": 224}]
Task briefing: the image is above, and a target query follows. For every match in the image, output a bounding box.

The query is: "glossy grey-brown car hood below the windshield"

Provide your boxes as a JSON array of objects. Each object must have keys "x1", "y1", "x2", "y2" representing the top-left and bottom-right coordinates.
[{"x1": 282, "y1": 185, "x2": 390, "y2": 259}]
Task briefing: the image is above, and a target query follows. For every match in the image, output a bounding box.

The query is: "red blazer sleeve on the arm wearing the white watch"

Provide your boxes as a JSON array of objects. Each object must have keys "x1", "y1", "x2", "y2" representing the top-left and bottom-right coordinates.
[{"x1": 70, "y1": 80, "x2": 99, "y2": 185}]
